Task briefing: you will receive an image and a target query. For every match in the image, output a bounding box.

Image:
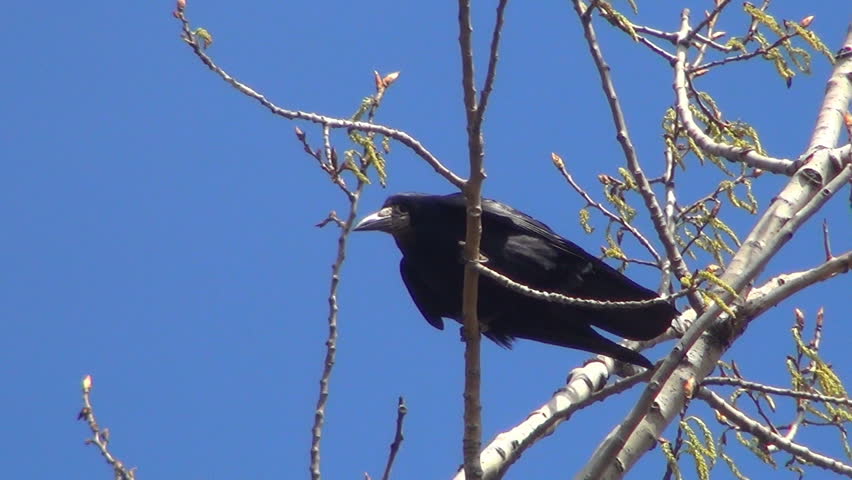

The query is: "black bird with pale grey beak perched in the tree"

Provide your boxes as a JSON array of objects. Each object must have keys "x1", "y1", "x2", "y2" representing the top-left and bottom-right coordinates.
[{"x1": 355, "y1": 193, "x2": 678, "y2": 368}]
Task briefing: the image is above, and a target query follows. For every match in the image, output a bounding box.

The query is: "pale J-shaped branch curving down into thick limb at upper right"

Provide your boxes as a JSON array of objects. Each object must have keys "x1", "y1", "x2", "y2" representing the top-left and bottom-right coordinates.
[{"x1": 673, "y1": 32, "x2": 801, "y2": 175}]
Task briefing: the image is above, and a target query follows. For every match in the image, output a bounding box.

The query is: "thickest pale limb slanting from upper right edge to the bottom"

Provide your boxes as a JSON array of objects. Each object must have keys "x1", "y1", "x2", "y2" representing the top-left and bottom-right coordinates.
[{"x1": 580, "y1": 19, "x2": 852, "y2": 479}]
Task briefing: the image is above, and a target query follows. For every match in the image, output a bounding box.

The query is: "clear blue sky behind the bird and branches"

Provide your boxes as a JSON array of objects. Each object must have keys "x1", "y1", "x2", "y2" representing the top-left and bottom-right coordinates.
[{"x1": 0, "y1": 0, "x2": 852, "y2": 479}]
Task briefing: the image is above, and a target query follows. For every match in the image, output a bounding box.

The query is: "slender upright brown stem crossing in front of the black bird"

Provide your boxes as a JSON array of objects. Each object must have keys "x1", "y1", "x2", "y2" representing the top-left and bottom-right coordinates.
[{"x1": 458, "y1": 0, "x2": 496, "y2": 480}]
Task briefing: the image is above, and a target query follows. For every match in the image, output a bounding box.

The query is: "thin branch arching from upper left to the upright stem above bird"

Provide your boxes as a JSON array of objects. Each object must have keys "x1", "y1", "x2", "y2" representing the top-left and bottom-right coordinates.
[{"x1": 175, "y1": 11, "x2": 464, "y2": 188}]
